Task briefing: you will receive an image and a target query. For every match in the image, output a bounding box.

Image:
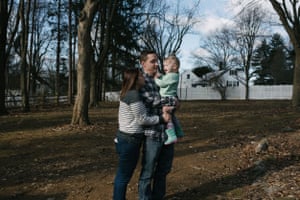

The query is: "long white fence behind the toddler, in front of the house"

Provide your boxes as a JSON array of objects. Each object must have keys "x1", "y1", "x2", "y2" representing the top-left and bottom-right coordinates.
[{"x1": 178, "y1": 85, "x2": 293, "y2": 100}]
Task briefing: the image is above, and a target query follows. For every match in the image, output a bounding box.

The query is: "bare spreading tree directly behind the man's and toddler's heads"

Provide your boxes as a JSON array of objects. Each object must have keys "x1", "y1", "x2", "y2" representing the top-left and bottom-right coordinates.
[{"x1": 141, "y1": 0, "x2": 200, "y2": 70}]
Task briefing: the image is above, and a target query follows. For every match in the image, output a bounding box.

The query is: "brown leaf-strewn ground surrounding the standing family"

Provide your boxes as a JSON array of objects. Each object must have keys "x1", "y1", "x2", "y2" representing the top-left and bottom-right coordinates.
[{"x1": 0, "y1": 101, "x2": 300, "y2": 200}]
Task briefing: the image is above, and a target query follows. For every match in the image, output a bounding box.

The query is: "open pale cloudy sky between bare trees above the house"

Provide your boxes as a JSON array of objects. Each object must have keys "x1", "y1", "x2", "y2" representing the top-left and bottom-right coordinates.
[{"x1": 180, "y1": 0, "x2": 284, "y2": 71}]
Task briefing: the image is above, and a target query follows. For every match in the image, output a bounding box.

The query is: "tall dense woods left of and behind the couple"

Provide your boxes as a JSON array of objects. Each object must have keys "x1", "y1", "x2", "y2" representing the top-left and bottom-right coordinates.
[{"x1": 0, "y1": 0, "x2": 199, "y2": 124}]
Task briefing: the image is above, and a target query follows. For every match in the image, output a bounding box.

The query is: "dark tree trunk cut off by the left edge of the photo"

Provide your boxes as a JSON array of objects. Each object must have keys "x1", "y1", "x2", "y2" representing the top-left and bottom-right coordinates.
[{"x1": 0, "y1": 0, "x2": 8, "y2": 115}]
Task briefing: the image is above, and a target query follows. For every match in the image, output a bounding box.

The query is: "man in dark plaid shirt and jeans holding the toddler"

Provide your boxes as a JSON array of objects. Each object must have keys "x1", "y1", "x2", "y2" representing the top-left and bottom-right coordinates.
[{"x1": 139, "y1": 51, "x2": 174, "y2": 200}]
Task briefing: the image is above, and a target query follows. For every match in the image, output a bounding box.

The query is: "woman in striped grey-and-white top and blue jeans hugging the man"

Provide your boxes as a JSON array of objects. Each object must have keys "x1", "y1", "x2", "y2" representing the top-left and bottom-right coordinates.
[{"x1": 113, "y1": 68, "x2": 170, "y2": 200}]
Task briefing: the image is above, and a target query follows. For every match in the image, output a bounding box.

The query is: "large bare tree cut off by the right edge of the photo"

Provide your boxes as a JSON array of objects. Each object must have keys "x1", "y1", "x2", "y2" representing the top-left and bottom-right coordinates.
[{"x1": 269, "y1": 0, "x2": 300, "y2": 107}]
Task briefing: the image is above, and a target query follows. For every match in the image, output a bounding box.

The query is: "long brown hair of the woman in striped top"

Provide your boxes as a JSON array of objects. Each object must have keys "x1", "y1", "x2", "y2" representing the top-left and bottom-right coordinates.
[{"x1": 120, "y1": 68, "x2": 140, "y2": 98}]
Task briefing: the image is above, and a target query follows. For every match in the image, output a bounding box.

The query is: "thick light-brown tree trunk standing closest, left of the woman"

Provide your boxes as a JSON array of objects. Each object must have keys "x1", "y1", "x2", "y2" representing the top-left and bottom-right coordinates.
[{"x1": 72, "y1": 0, "x2": 99, "y2": 126}]
